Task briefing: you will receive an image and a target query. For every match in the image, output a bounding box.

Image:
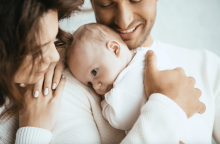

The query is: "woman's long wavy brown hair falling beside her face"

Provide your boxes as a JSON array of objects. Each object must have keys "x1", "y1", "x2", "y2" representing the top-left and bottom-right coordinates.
[{"x1": 0, "y1": 0, "x2": 84, "y2": 119}]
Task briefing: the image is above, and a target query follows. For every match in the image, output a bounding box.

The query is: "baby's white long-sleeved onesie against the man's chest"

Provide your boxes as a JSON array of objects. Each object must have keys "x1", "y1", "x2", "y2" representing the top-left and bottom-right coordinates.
[{"x1": 101, "y1": 43, "x2": 170, "y2": 132}]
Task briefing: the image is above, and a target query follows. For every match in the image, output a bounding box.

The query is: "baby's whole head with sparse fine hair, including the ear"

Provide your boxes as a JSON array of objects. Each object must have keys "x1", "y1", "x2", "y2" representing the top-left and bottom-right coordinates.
[{"x1": 66, "y1": 23, "x2": 132, "y2": 95}]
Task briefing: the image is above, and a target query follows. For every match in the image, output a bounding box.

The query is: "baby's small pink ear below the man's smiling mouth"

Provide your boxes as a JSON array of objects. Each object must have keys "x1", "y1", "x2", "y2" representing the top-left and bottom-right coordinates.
[{"x1": 106, "y1": 40, "x2": 121, "y2": 57}]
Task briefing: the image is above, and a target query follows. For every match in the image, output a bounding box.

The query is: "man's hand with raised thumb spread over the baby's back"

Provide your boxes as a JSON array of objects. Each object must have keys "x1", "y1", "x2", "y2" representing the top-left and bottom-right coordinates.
[{"x1": 144, "y1": 50, "x2": 206, "y2": 118}]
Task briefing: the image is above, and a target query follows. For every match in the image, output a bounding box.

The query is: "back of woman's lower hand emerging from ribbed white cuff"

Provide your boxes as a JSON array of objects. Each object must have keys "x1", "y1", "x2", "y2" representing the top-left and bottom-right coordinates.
[{"x1": 19, "y1": 76, "x2": 66, "y2": 131}]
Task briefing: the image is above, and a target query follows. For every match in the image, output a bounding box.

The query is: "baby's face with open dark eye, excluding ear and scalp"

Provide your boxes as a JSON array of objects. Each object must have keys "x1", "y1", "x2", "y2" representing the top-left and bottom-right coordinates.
[{"x1": 68, "y1": 43, "x2": 125, "y2": 95}]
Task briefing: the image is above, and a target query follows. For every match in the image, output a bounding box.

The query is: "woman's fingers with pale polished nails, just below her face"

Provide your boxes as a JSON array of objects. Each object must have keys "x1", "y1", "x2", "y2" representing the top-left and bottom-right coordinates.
[{"x1": 33, "y1": 48, "x2": 66, "y2": 97}]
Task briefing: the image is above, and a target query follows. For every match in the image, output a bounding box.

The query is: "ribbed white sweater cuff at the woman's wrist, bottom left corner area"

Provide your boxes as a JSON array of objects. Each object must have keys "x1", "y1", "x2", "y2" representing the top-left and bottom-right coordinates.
[{"x1": 15, "y1": 127, "x2": 52, "y2": 144}]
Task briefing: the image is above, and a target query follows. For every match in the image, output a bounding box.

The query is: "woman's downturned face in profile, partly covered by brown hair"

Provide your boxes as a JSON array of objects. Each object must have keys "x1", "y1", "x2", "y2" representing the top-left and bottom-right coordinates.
[{"x1": 14, "y1": 10, "x2": 60, "y2": 84}]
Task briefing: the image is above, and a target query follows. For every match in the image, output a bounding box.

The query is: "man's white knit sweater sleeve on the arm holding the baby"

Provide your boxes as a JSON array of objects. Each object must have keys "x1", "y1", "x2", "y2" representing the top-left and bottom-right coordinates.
[{"x1": 121, "y1": 94, "x2": 187, "y2": 144}]
